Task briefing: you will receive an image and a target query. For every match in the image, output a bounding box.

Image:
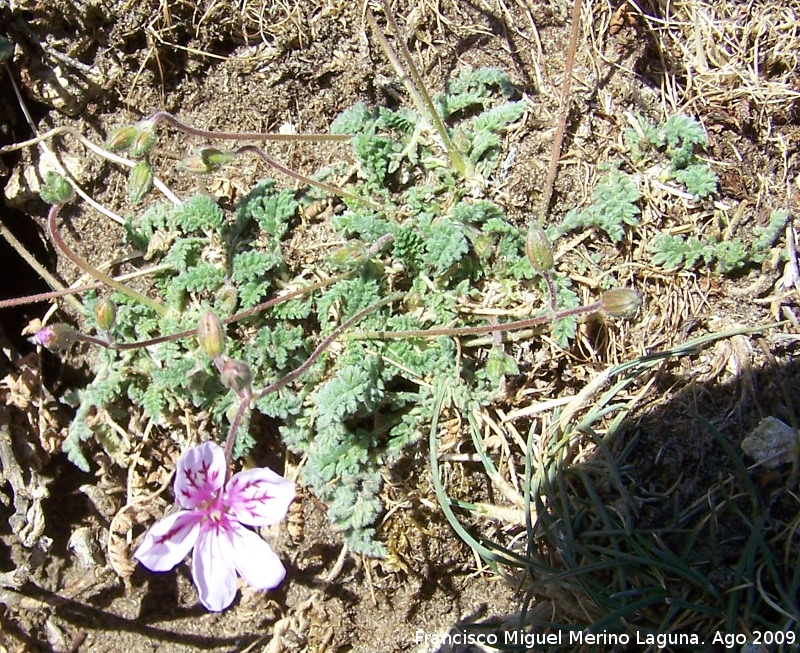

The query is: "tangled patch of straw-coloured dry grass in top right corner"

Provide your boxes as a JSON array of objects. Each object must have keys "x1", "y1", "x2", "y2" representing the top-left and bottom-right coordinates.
[{"x1": 630, "y1": 0, "x2": 800, "y2": 134}]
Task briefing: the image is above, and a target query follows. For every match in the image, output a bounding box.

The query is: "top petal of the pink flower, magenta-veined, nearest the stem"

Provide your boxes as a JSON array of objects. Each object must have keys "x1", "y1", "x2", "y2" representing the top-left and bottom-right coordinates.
[{"x1": 175, "y1": 442, "x2": 228, "y2": 509}]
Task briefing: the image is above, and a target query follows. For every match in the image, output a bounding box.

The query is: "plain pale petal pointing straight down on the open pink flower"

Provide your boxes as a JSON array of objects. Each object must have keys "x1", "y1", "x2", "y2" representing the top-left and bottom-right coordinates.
[{"x1": 192, "y1": 527, "x2": 236, "y2": 612}]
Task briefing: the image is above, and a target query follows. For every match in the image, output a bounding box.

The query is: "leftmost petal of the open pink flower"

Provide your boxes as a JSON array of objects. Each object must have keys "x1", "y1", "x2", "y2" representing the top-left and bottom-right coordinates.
[{"x1": 133, "y1": 510, "x2": 202, "y2": 571}]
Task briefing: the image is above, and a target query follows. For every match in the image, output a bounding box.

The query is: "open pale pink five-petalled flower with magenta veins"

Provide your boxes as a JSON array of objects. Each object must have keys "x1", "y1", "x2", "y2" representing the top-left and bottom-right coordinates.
[{"x1": 134, "y1": 442, "x2": 295, "y2": 611}]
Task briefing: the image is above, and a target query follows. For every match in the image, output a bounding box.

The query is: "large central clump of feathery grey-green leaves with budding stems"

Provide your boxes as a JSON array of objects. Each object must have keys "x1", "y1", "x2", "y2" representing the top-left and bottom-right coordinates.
[{"x1": 0, "y1": 10, "x2": 638, "y2": 555}]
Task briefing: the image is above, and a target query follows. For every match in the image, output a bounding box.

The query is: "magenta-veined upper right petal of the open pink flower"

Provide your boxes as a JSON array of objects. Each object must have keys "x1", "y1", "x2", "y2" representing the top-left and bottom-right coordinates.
[{"x1": 223, "y1": 467, "x2": 295, "y2": 526}]
